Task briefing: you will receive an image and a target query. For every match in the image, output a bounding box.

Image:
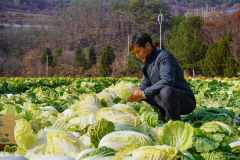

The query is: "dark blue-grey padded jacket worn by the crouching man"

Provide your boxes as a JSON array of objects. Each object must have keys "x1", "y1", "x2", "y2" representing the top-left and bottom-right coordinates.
[{"x1": 139, "y1": 48, "x2": 194, "y2": 98}]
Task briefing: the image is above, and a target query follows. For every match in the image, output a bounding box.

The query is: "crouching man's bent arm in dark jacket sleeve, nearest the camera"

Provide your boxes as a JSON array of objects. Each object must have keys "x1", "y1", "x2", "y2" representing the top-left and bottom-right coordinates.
[{"x1": 144, "y1": 55, "x2": 176, "y2": 98}]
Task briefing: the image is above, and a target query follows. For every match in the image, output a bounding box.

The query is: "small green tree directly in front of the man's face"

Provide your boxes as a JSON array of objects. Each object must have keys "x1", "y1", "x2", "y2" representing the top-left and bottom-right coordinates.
[{"x1": 126, "y1": 52, "x2": 141, "y2": 74}]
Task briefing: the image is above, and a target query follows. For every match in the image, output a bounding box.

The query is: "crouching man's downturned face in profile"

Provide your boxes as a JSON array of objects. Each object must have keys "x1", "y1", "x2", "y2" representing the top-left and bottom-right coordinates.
[{"x1": 132, "y1": 43, "x2": 152, "y2": 62}]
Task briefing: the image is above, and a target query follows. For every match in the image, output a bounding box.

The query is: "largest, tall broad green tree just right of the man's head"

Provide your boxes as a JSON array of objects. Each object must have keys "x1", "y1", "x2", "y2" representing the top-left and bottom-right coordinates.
[{"x1": 166, "y1": 16, "x2": 204, "y2": 70}]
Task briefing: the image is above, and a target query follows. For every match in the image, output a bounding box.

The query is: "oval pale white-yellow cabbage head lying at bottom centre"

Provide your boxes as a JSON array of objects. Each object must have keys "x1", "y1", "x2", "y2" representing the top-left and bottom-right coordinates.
[{"x1": 99, "y1": 131, "x2": 153, "y2": 153}]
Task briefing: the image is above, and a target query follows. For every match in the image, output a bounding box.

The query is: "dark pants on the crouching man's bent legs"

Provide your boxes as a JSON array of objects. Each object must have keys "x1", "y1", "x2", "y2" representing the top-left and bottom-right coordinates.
[{"x1": 145, "y1": 86, "x2": 196, "y2": 122}]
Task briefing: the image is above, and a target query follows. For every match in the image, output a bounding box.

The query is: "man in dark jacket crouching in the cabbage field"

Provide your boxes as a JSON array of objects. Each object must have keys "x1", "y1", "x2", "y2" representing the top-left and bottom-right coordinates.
[{"x1": 127, "y1": 32, "x2": 196, "y2": 122}]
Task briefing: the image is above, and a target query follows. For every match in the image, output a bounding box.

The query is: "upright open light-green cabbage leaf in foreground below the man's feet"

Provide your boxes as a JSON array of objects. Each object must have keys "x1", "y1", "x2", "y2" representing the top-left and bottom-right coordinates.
[{"x1": 158, "y1": 120, "x2": 194, "y2": 152}]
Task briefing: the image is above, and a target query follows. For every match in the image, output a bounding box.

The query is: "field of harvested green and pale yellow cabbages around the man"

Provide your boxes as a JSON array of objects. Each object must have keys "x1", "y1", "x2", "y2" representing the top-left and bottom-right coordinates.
[{"x1": 0, "y1": 77, "x2": 240, "y2": 160}]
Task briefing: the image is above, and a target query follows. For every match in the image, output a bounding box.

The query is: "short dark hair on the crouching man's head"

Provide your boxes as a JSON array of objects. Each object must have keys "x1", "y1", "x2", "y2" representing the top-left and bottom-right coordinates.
[{"x1": 129, "y1": 32, "x2": 153, "y2": 51}]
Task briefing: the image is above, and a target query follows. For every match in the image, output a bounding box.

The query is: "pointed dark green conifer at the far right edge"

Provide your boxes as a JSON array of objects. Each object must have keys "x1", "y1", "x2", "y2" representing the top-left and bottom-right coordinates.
[{"x1": 201, "y1": 32, "x2": 237, "y2": 77}]
